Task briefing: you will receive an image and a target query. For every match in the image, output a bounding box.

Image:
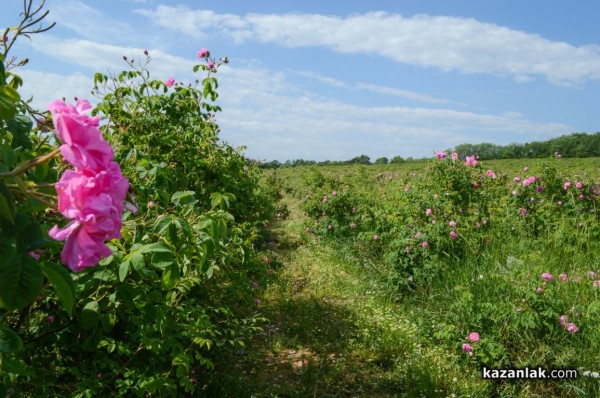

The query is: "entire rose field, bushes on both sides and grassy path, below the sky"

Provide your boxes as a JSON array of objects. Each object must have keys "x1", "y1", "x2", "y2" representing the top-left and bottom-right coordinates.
[{"x1": 0, "y1": 1, "x2": 600, "y2": 397}]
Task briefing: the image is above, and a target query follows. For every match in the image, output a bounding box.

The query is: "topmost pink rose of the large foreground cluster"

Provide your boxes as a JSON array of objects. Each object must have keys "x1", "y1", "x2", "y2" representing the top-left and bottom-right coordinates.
[{"x1": 48, "y1": 99, "x2": 113, "y2": 171}]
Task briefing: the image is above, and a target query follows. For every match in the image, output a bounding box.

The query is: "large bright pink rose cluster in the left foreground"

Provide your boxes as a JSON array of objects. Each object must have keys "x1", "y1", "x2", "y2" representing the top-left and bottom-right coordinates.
[{"x1": 48, "y1": 99, "x2": 129, "y2": 272}]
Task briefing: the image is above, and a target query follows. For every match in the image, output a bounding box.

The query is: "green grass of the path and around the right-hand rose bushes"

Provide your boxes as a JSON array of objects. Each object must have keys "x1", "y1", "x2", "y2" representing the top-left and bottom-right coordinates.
[{"x1": 205, "y1": 159, "x2": 600, "y2": 398}]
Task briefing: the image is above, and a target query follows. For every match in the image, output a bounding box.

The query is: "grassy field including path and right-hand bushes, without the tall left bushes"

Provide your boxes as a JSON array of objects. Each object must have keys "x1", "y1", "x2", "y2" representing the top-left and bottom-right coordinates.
[{"x1": 205, "y1": 159, "x2": 600, "y2": 397}]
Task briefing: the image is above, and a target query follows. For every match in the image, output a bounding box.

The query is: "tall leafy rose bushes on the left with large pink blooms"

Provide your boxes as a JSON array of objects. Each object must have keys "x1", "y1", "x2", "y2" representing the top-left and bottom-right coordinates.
[{"x1": 0, "y1": 3, "x2": 274, "y2": 396}]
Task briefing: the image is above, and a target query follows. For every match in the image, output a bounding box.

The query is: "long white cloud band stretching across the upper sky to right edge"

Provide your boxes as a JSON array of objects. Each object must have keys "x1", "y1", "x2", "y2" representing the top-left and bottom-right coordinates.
[{"x1": 136, "y1": 5, "x2": 600, "y2": 85}]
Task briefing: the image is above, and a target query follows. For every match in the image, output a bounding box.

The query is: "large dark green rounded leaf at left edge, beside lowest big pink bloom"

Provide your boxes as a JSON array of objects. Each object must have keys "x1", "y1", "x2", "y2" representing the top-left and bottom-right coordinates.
[{"x1": 0, "y1": 254, "x2": 44, "y2": 310}]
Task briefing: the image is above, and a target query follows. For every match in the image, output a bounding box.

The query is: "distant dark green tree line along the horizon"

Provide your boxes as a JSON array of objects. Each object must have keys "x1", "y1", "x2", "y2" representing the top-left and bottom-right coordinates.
[{"x1": 260, "y1": 132, "x2": 600, "y2": 169}]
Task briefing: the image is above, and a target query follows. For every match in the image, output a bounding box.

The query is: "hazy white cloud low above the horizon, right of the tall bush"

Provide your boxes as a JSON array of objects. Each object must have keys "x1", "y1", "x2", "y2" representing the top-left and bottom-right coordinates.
[{"x1": 218, "y1": 63, "x2": 571, "y2": 161}]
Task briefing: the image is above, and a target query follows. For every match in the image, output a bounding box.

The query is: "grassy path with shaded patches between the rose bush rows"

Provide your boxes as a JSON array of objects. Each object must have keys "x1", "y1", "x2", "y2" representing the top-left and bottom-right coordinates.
[{"x1": 204, "y1": 198, "x2": 485, "y2": 397}]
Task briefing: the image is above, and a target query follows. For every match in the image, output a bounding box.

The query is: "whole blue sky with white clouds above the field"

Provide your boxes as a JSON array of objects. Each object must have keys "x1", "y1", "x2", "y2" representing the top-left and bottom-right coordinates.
[{"x1": 0, "y1": 0, "x2": 600, "y2": 161}]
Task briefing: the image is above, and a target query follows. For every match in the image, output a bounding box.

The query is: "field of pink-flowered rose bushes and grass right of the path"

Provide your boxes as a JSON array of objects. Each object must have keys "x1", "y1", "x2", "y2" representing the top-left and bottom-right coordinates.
[{"x1": 264, "y1": 153, "x2": 600, "y2": 397}]
